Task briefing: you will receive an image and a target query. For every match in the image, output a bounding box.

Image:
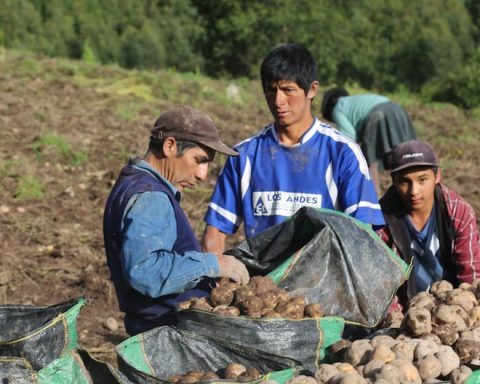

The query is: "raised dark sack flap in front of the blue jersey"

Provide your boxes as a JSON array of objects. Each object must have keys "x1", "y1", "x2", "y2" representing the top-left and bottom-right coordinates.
[{"x1": 225, "y1": 207, "x2": 411, "y2": 328}]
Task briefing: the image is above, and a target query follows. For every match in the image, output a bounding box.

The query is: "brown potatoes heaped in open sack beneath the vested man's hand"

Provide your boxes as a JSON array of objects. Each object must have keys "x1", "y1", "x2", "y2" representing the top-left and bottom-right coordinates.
[{"x1": 178, "y1": 276, "x2": 323, "y2": 319}]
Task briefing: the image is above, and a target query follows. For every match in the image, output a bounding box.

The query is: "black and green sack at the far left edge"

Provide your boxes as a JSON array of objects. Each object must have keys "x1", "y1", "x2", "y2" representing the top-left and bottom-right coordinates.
[{"x1": 0, "y1": 297, "x2": 87, "y2": 371}]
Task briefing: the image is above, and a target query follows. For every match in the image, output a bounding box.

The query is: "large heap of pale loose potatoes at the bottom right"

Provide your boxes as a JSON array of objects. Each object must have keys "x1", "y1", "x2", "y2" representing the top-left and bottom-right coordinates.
[{"x1": 300, "y1": 280, "x2": 480, "y2": 384}]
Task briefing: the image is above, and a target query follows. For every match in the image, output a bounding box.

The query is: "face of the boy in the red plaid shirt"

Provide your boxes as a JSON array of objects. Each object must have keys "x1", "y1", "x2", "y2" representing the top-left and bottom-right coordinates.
[{"x1": 393, "y1": 167, "x2": 440, "y2": 211}]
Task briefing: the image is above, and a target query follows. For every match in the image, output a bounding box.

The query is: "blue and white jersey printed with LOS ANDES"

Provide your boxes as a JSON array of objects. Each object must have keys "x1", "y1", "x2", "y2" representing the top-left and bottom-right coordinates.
[{"x1": 205, "y1": 119, "x2": 384, "y2": 237}]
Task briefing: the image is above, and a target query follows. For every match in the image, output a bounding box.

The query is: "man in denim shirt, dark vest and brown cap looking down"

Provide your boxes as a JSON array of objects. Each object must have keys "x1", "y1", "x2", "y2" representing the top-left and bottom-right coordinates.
[{"x1": 103, "y1": 107, "x2": 249, "y2": 335}]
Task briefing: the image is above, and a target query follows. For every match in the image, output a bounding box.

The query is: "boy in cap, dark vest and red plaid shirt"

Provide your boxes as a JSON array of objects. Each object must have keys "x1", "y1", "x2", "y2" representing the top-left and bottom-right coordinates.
[{"x1": 378, "y1": 140, "x2": 480, "y2": 303}]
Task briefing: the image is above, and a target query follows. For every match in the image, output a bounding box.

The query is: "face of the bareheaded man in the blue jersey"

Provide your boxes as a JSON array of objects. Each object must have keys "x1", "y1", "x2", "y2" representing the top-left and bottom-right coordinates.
[{"x1": 264, "y1": 80, "x2": 318, "y2": 127}]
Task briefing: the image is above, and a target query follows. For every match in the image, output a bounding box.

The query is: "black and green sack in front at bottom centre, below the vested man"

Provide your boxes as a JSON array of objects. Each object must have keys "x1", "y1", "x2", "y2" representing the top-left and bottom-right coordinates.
[{"x1": 117, "y1": 327, "x2": 301, "y2": 384}]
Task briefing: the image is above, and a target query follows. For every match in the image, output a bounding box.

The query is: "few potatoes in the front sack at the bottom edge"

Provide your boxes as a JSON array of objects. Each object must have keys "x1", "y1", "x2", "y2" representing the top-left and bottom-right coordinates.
[{"x1": 167, "y1": 363, "x2": 261, "y2": 384}]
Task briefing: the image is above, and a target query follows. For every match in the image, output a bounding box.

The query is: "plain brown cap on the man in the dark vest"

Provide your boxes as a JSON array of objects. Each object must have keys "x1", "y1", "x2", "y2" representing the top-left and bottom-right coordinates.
[{"x1": 150, "y1": 107, "x2": 238, "y2": 156}]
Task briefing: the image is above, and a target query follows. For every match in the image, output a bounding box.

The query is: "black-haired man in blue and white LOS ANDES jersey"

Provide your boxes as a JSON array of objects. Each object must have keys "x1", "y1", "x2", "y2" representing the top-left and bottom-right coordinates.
[{"x1": 202, "y1": 44, "x2": 384, "y2": 254}]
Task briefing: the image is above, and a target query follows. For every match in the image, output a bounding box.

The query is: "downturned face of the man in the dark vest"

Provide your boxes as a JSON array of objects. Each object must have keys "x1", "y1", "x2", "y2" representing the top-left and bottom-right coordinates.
[{"x1": 166, "y1": 146, "x2": 215, "y2": 191}]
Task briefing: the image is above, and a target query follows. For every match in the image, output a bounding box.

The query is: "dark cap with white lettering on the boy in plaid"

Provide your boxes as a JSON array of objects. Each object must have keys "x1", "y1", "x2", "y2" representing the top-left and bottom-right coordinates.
[{"x1": 386, "y1": 140, "x2": 439, "y2": 173}]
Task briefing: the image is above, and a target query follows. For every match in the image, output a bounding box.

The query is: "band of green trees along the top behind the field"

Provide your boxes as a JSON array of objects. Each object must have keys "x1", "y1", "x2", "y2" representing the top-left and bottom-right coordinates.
[{"x1": 0, "y1": 0, "x2": 480, "y2": 108}]
